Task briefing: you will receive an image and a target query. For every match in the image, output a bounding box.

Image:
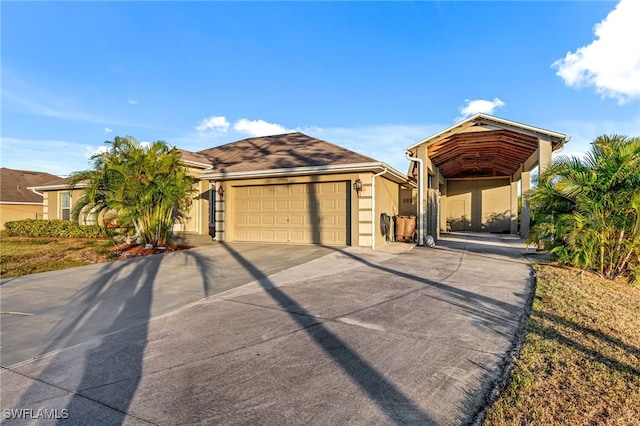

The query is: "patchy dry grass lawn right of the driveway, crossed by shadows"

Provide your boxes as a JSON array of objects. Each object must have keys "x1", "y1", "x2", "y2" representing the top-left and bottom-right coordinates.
[{"x1": 484, "y1": 265, "x2": 640, "y2": 425}]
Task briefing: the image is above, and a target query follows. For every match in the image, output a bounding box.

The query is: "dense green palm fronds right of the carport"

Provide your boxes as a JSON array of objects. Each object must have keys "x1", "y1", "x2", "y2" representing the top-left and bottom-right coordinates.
[{"x1": 528, "y1": 135, "x2": 640, "y2": 281}]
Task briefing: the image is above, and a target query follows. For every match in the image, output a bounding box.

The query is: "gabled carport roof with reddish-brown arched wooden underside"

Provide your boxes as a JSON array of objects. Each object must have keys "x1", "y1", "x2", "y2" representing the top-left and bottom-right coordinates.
[{"x1": 408, "y1": 114, "x2": 569, "y2": 178}]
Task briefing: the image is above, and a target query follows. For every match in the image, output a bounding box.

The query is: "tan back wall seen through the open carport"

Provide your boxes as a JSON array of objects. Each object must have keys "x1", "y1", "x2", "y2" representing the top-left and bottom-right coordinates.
[{"x1": 441, "y1": 178, "x2": 511, "y2": 232}]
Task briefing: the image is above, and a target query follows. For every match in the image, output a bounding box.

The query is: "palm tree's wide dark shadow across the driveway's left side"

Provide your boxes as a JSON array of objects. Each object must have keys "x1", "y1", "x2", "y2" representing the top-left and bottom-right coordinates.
[{"x1": 3, "y1": 250, "x2": 216, "y2": 426}]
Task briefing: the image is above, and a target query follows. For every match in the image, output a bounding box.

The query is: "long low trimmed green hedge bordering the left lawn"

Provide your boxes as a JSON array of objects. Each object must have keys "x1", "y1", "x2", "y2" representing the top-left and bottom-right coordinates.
[{"x1": 4, "y1": 219, "x2": 115, "y2": 238}]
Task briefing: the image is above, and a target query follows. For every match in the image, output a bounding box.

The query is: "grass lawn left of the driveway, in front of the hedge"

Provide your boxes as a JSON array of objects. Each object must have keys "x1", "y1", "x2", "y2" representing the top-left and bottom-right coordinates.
[{"x1": 0, "y1": 237, "x2": 113, "y2": 278}]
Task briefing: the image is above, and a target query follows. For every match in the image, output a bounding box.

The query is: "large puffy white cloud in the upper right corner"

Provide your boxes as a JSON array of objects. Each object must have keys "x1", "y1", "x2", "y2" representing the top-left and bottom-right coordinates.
[{"x1": 551, "y1": 0, "x2": 640, "y2": 103}]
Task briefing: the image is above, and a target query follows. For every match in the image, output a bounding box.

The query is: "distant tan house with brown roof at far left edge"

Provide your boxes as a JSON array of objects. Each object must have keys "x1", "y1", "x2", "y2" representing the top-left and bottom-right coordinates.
[{"x1": 0, "y1": 167, "x2": 63, "y2": 229}]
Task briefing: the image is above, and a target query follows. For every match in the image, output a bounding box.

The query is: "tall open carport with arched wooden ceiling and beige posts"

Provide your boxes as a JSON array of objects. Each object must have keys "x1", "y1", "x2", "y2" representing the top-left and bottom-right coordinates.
[{"x1": 407, "y1": 114, "x2": 569, "y2": 241}]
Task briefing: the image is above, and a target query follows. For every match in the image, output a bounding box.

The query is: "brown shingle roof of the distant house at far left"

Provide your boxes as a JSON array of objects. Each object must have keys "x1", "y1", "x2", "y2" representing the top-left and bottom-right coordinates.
[{"x1": 0, "y1": 167, "x2": 66, "y2": 203}]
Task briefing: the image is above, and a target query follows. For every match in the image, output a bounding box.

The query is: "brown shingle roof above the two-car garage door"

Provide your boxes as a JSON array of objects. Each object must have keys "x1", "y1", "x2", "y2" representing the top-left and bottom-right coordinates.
[{"x1": 182, "y1": 132, "x2": 376, "y2": 173}]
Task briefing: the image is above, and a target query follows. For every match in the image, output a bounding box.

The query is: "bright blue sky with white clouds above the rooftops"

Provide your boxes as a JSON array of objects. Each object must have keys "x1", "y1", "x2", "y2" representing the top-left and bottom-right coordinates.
[{"x1": 0, "y1": 0, "x2": 640, "y2": 176}]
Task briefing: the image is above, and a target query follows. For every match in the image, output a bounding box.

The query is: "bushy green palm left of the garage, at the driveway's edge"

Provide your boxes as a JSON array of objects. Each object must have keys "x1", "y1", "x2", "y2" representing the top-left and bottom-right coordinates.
[{"x1": 70, "y1": 137, "x2": 196, "y2": 246}]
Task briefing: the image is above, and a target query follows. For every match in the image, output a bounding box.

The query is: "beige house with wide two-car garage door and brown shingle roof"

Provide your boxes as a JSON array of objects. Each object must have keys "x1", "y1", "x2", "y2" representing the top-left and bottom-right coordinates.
[{"x1": 33, "y1": 133, "x2": 416, "y2": 247}]
